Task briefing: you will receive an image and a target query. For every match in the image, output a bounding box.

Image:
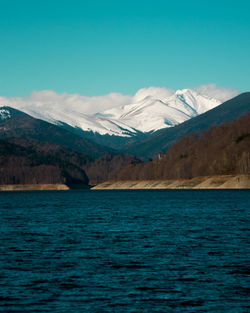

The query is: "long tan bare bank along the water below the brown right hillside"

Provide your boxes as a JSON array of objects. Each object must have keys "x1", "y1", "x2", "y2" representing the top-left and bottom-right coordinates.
[{"x1": 91, "y1": 174, "x2": 250, "y2": 190}]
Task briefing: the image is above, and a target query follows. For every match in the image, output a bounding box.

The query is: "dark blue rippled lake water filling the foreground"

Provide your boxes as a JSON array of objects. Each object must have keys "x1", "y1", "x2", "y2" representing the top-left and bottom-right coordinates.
[{"x1": 0, "y1": 190, "x2": 250, "y2": 313}]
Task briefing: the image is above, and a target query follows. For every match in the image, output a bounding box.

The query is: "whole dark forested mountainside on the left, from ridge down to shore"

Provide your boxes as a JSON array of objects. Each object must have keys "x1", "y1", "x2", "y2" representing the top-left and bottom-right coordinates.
[{"x1": 0, "y1": 107, "x2": 139, "y2": 186}]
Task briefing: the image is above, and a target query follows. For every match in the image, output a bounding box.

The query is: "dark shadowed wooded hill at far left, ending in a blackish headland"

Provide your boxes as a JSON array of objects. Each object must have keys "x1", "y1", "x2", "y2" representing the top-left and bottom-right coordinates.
[{"x1": 0, "y1": 139, "x2": 88, "y2": 186}]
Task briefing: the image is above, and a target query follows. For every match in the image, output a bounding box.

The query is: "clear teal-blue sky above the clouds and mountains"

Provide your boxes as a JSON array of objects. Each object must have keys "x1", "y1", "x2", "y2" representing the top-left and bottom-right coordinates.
[{"x1": 0, "y1": 0, "x2": 250, "y2": 96}]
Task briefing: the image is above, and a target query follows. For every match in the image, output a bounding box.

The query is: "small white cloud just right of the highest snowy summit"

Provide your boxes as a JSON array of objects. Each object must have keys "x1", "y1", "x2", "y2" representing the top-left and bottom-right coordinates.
[{"x1": 193, "y1": 84, "x2": 241, "y2": 102}]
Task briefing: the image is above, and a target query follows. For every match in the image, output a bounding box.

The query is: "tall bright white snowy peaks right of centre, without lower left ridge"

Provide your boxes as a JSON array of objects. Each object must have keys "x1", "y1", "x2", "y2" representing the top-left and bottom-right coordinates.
[{"x1": 105, "y1": 89, "x2": 221, "y2": 132}]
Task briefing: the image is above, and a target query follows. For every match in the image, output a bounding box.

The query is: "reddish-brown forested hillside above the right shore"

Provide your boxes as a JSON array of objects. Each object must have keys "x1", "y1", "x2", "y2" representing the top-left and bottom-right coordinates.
[{"x1": 112, "y1": 114, "x2": 250, "y2": 180}]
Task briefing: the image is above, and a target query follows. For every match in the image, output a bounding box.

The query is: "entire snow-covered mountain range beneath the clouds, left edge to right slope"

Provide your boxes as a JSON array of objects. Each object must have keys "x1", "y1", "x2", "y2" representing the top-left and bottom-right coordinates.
[{"x1": 0, "y1": 87, "x2": 235, "y2": 137}]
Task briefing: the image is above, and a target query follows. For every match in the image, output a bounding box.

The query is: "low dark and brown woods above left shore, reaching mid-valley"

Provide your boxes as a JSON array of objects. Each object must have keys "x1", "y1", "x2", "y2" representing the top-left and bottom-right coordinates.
[{"x1": 0, "y1": 138, "x2": 138, "y2": 186}]
